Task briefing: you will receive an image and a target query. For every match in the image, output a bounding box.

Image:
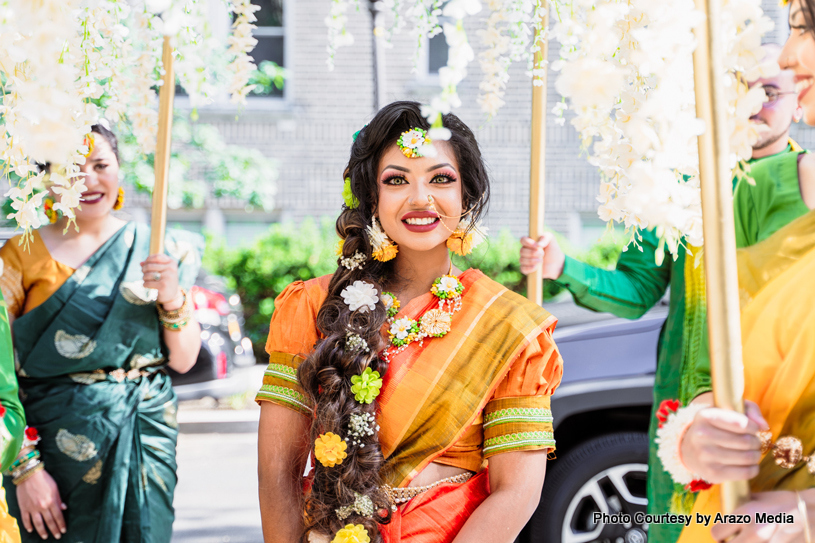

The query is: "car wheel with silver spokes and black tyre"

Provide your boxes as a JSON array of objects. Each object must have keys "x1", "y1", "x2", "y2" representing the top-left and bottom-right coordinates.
[{"x1": 526, "y1": 432, "x2": 648, "y2": 543}]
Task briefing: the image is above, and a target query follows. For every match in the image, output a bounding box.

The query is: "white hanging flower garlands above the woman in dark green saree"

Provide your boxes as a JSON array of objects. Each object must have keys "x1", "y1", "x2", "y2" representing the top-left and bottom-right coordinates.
[{"x1": 0, "y1": 0, "x2": 258, "y2": 244}]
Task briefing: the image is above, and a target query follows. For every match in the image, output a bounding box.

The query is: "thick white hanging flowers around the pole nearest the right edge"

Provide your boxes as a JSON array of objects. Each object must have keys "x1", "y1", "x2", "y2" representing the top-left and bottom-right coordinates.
[{"x1": 552, "y1": 0, "x2": 772, "y2": 255}]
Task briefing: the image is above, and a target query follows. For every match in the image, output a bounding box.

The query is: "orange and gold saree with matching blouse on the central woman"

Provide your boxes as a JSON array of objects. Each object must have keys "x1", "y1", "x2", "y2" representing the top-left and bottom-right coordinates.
[{"x1": 257, "y1": 270, "x2": 562, "y2": 543}]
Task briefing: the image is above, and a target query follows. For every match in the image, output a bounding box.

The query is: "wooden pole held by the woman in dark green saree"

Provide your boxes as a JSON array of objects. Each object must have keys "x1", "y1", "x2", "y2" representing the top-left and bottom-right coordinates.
[{"x1": 150, "y1": 36, "x2": 175, "y2": 255}]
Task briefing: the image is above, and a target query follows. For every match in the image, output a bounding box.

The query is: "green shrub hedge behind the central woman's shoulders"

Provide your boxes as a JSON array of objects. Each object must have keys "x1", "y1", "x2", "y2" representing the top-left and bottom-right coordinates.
[{"x1": 204, "y1": 218, "x2": 622, "y2": 360}]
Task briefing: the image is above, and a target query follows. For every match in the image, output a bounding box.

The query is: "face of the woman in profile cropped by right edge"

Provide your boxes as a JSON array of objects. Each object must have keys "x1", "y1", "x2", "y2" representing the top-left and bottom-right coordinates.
[{"x1": 778, "y1": 0, "x2": 815, "y2": 126}]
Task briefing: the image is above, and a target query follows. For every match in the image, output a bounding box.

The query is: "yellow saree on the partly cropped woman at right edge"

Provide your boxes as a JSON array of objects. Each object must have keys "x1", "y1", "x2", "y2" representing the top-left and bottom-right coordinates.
[{"x1": 679, "y1": 212, "x2": 815, "y2": 543}]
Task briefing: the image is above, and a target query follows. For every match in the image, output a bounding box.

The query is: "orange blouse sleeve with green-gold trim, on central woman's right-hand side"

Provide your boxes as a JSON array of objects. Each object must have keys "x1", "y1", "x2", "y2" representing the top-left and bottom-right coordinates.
[{"x1": 484, "y1": 324, "x2": 563, "y2": 458}]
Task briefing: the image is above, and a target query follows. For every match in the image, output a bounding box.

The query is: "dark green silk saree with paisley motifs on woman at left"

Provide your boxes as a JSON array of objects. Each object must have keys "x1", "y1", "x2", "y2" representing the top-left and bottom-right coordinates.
[{"x1": 4, "y1": 223, "x2": 200, "y2": 543}]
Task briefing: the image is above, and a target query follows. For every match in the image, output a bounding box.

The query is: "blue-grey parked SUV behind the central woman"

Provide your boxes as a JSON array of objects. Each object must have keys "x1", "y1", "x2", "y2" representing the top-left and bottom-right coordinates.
[{"x1": 518, "y1": 302, "x2": 667, "y2": 543}]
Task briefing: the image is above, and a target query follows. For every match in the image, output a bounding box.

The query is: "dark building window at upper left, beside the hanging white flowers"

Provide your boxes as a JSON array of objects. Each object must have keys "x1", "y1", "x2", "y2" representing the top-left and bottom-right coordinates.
[{"x1": 250, "y1": 0, "x2": 286, "y2": 98}]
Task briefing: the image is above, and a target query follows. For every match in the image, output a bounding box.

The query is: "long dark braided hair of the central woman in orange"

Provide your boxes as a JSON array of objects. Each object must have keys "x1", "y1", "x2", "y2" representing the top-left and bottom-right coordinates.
[{"x1": 298, "y1": 102, "x2": 489, "y2": 543}]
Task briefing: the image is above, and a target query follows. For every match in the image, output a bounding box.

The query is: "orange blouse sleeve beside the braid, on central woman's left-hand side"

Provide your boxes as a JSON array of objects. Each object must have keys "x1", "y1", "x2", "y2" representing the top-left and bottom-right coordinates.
[{"x1": 255, "y1": 277, "x2": 330, "y2": 415}]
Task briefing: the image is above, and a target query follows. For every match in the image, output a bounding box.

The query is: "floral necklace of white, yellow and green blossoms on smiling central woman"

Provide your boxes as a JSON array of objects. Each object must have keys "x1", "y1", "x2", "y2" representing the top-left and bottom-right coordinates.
[{"x1": 380, "y1": 272, "x2": 464, "y2": 361}]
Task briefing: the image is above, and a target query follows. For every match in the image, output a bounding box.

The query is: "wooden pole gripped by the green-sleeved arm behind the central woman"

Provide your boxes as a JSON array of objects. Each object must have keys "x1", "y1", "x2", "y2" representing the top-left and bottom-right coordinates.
[{"x1": 526, "y1": 2, "x2": 549, "y2": 305}]
